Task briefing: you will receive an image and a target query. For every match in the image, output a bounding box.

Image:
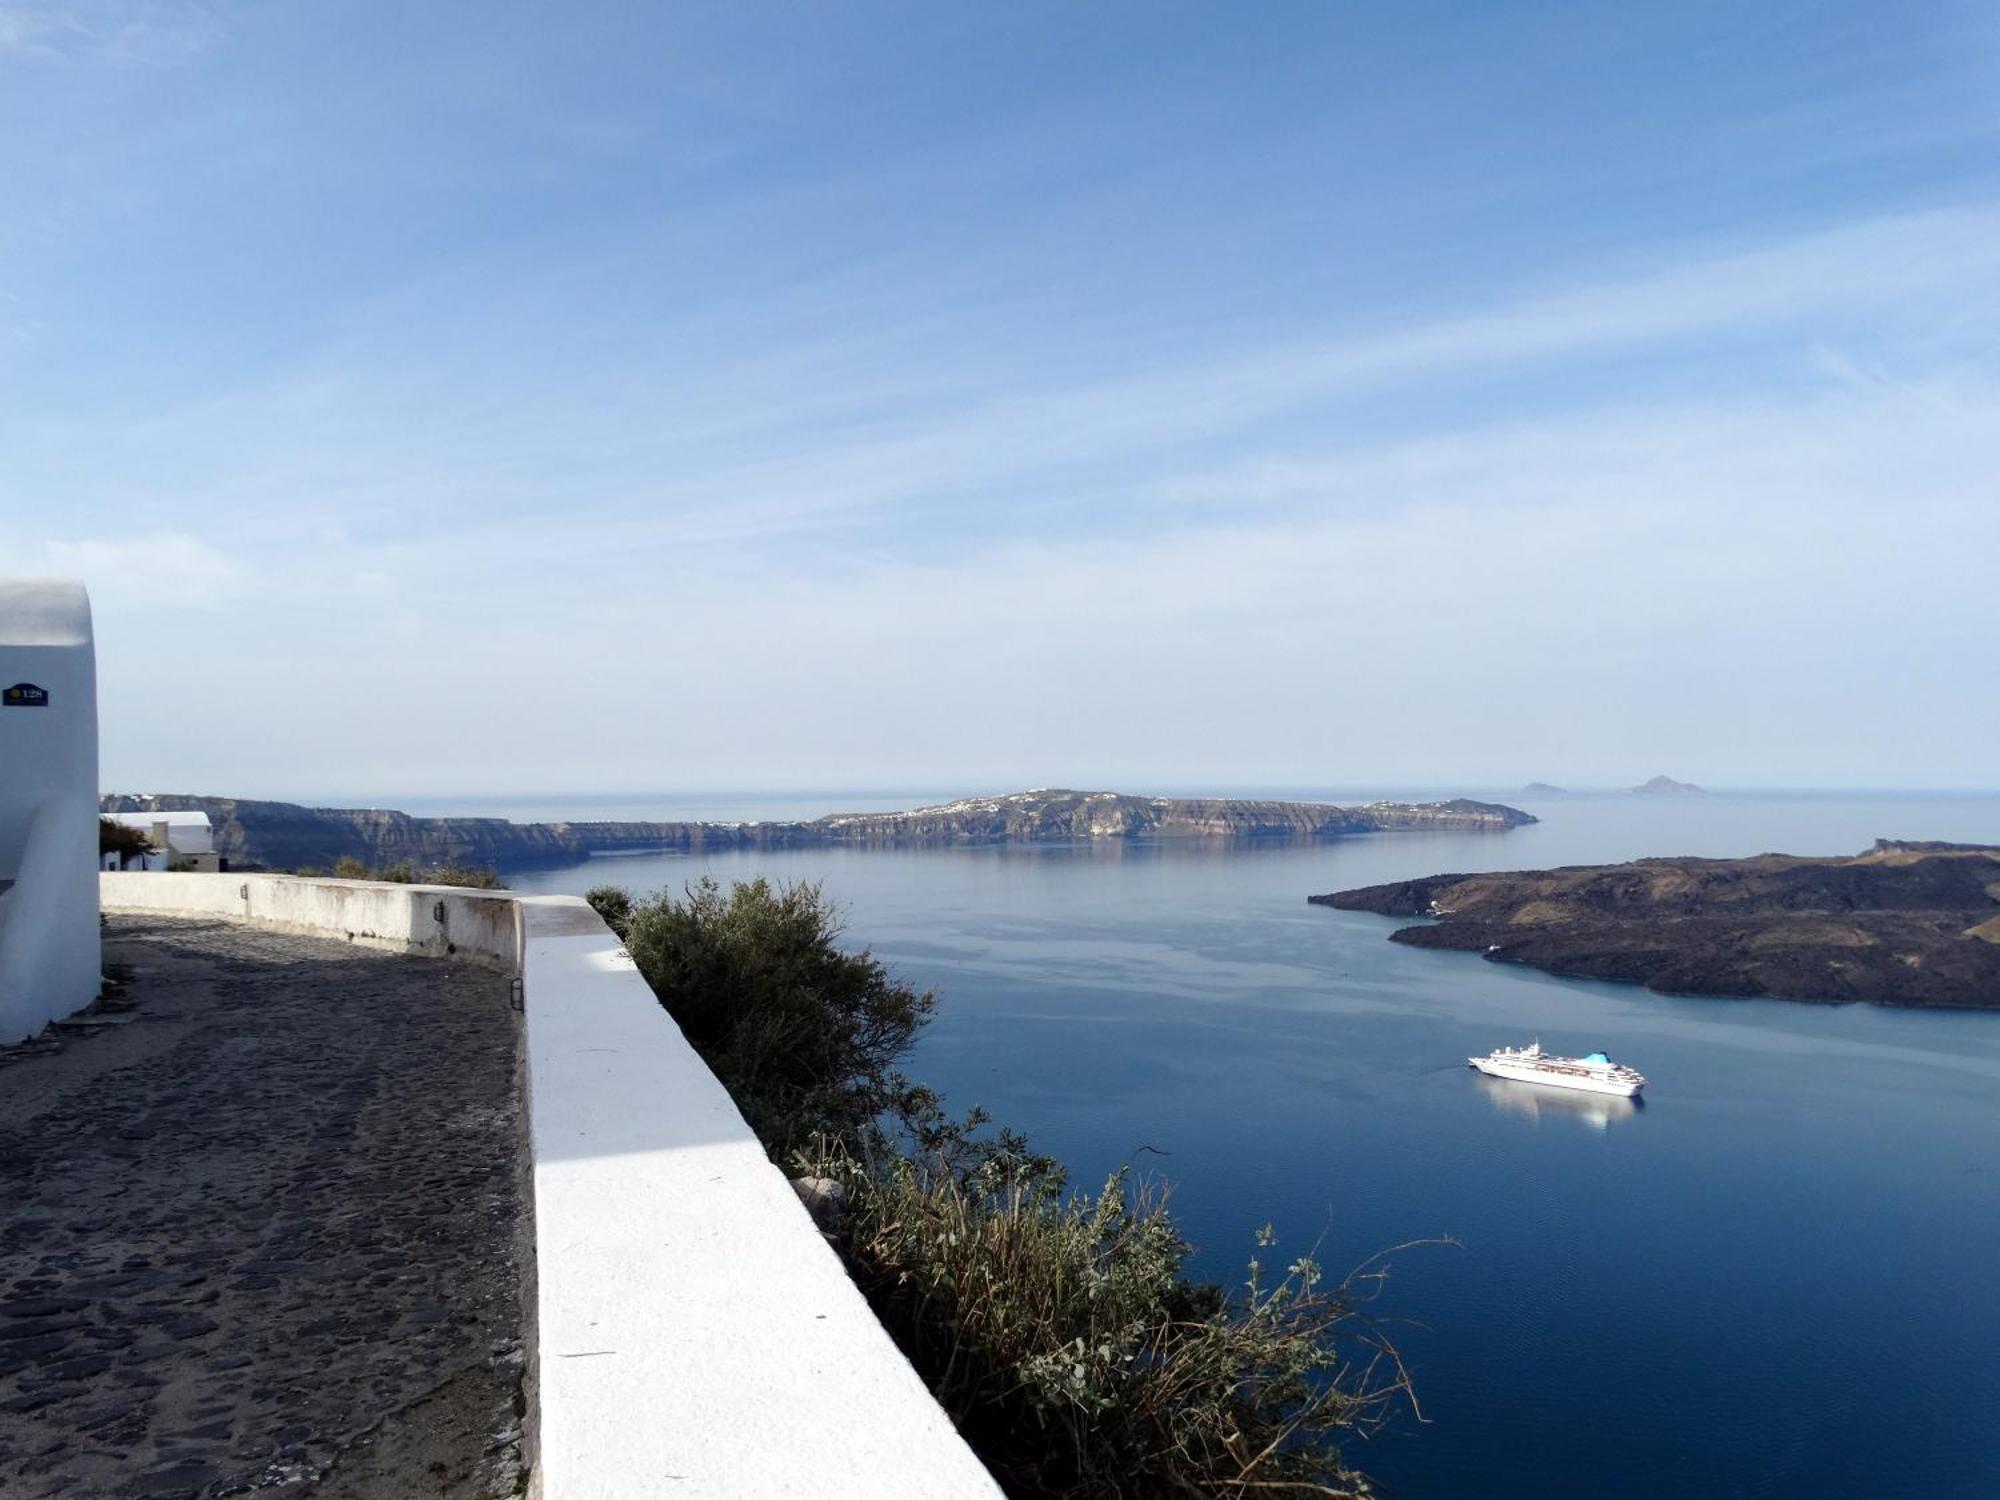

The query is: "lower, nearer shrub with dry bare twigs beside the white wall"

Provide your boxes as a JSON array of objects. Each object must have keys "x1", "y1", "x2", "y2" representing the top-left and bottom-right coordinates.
[{"x1": 800, "y1": 1146, "x2": 1408, "y2": 1500}]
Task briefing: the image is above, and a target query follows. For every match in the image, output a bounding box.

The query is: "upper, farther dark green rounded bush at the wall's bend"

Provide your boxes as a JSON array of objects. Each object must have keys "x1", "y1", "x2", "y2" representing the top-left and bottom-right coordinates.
[{"x1": 620, "y1": 878, "x2": 934, "y2": 1156}]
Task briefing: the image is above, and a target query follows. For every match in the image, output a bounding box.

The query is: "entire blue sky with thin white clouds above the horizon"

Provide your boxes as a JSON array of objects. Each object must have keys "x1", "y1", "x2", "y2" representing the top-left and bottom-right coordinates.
[{"x1": 0, "y1": 0, "x2": 2000, "y2": 796}]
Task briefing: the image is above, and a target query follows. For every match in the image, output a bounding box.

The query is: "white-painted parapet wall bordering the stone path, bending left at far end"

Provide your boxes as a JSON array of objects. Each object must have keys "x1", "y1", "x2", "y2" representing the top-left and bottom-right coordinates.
[{"x1": 100, "y1": 872, "x2": 1000, "y2": 1500}]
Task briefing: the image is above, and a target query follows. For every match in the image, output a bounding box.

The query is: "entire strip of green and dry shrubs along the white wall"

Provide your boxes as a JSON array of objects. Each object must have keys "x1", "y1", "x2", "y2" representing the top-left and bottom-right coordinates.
[{"x1": 588, "y1": 880, "x2": 1408, "y2": 1500}]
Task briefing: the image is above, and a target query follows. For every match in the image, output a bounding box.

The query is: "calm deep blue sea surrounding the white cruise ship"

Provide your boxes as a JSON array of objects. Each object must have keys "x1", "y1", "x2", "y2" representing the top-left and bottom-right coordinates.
[{"x1": 500, "y1": 796, "x2": 2000, "y2": 1500}]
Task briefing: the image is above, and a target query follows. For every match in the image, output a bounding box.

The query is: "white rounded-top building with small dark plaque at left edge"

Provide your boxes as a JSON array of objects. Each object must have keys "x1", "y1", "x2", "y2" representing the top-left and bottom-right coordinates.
[{"x1": 0, "y1": 578, "x2": 102, "y2": 1042}]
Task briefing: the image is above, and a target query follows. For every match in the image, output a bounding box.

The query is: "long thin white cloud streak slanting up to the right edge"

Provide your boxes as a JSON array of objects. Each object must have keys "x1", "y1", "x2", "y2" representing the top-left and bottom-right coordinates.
[{"x1": 540, "y1": 206, "x2": 2000, "y2": 540}]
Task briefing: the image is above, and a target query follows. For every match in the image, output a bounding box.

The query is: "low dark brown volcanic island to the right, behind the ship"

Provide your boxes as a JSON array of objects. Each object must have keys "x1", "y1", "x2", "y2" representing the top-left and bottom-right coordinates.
[{"x1": 1310, "y1": 840, "x2": 2000, "y2": 1010}]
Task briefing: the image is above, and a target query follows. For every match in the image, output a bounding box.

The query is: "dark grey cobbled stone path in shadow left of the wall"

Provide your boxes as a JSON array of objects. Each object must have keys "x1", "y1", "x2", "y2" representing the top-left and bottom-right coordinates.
[{"x1": 0, "y1": 916, "x2": 526, "y2": 1500}]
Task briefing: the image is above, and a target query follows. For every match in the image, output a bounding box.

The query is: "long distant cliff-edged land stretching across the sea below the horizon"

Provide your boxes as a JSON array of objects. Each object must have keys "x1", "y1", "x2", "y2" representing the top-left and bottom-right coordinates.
[{"x1": 104, "y1": 790, "x2": 1534, "y2": 870}]
